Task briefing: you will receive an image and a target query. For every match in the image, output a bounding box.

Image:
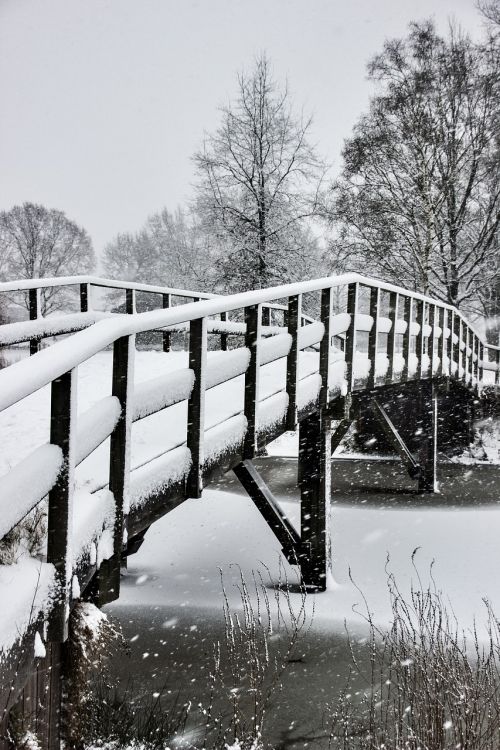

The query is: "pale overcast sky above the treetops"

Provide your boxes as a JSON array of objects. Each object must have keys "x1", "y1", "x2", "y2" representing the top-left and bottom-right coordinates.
[{"x1": 0, "y1": 0, "x2": 481, "y2": 252}]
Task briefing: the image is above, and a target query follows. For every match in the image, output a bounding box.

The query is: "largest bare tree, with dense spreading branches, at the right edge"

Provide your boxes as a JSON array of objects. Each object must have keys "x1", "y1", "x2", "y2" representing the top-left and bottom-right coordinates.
[{"x1": 331, "y1": 21, "x2": 500, "y2": 307}]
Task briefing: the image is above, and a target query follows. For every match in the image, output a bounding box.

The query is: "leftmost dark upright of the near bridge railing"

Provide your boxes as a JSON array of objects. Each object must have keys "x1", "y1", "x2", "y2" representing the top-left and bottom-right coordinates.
[{"x1": 47, "y1": 369, "x2": 77, "y2": 643}]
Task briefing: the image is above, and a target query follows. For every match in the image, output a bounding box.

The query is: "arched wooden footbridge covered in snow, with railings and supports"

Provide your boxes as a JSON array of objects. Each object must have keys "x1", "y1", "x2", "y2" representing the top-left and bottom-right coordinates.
[{"x1": 0, "y1": 274, "x2": 500, "y2": 748}]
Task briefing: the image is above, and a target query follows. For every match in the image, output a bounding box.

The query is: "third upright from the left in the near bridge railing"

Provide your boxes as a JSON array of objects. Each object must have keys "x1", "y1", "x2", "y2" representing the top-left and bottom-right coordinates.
[{"x1": 186, "y1": 318, "x2": 207, "y2": 497}]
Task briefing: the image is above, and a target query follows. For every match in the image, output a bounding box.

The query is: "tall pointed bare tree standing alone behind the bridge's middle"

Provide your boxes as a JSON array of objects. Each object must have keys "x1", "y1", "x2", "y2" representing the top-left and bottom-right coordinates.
[{"x1": 194, "y1": 55, "x2": 324, "y2": 290}]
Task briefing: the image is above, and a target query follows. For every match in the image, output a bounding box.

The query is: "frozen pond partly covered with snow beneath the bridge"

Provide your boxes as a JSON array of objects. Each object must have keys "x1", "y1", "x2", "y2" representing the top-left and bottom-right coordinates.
[{"x1": 104, "y1": 457, "x2": 500, "y2": 748}]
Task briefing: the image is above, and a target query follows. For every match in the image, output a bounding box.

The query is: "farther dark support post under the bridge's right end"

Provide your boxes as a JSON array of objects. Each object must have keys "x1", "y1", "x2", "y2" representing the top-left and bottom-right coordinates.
[{"x1": 418, "y1": 381, "x2": 438, "y2": 492}]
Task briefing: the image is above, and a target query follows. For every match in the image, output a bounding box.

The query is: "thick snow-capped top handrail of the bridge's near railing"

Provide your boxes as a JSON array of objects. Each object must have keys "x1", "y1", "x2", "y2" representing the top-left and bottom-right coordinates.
[{"x1": 0, "y1": 273, "x2": 500, "y2": 418}]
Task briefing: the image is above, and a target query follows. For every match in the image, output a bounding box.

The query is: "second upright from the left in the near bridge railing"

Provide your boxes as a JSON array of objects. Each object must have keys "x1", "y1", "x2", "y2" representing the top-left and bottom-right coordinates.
[{"x1": 99, "y1": 336, "x2": 135, "y2": 604}]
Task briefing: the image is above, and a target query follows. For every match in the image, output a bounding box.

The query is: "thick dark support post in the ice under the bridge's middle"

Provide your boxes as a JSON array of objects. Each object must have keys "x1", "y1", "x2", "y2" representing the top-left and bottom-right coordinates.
[{"x1": 299, "y1": 411, "x2": 331, "y2": 591}]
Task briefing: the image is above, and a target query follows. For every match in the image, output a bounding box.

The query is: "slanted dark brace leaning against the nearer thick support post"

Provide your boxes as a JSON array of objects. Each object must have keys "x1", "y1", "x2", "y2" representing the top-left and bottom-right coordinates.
[{"x1": 233, "y1": 460, "x2": 301, "y2": 565}]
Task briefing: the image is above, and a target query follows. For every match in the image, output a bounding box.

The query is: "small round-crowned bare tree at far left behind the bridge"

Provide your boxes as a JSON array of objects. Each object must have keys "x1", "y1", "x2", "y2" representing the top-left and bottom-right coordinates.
[{"x1": 0, "y1": 203, "x2": 95, "y2": 314}]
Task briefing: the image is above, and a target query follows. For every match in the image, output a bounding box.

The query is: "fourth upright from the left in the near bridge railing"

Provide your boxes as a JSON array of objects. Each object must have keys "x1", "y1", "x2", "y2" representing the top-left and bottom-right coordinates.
[{"x1": 243, "y1": 305, "x2": 262, "y2": 459}]
